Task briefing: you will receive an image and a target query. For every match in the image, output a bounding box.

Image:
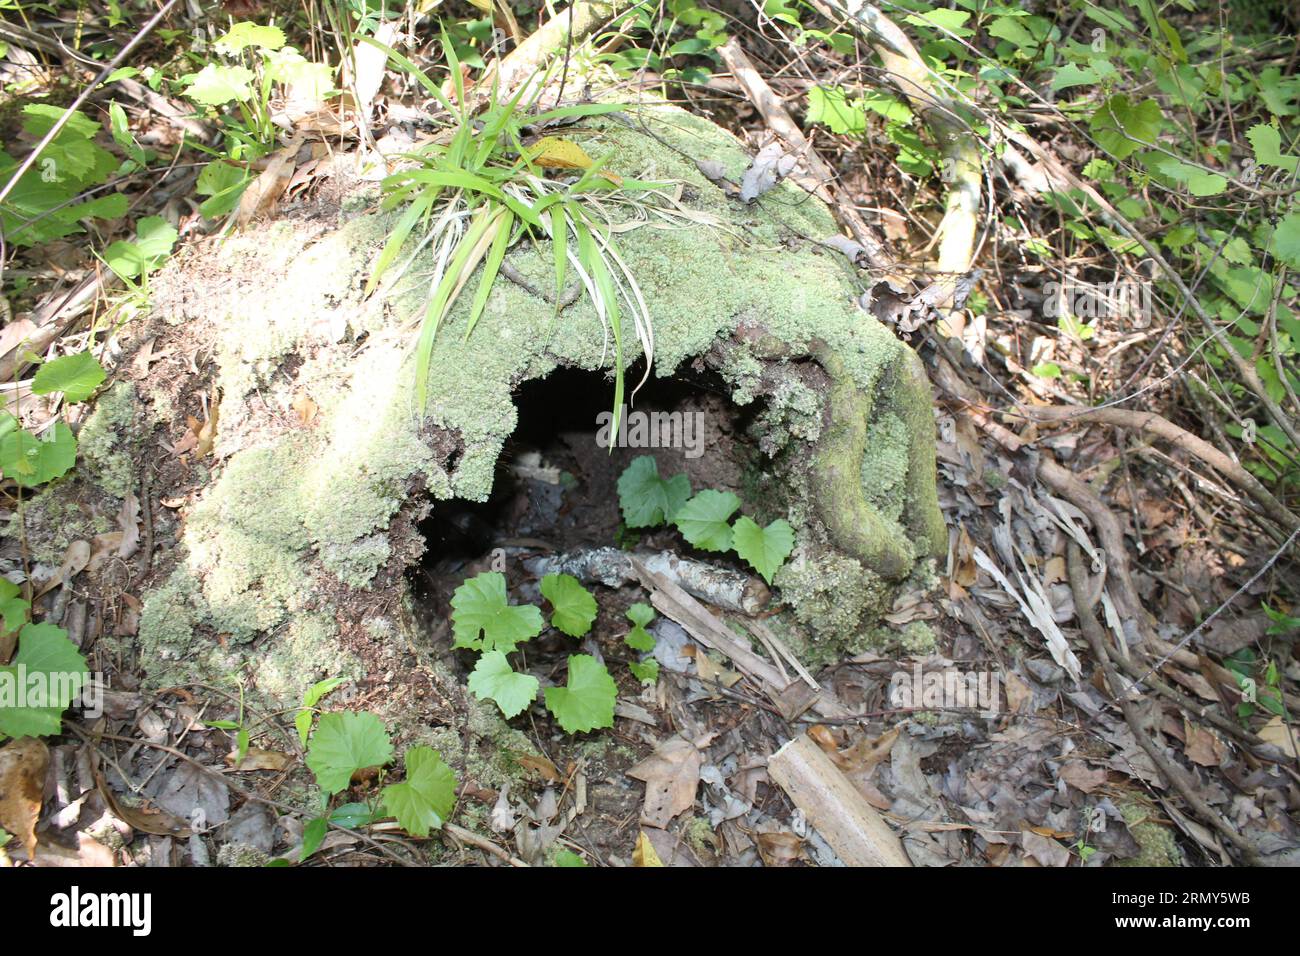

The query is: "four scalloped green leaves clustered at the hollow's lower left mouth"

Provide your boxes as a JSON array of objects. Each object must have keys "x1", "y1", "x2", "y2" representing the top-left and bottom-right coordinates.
[{"x1": 451, "y1": 571, "x2": 618, "y2": 734}]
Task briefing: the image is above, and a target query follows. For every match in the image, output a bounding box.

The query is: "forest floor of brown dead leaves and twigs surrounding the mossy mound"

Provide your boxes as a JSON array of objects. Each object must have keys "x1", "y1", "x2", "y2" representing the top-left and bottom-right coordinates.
[{"x1": 0, "y1": 1, "x2": 1300, "y2": 866}]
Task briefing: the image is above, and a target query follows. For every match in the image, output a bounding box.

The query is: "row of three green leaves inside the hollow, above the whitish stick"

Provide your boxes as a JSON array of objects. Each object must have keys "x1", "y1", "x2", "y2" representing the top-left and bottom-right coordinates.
[{"x1": 619, "y1": 455, "x2": 794, "y2": 584}]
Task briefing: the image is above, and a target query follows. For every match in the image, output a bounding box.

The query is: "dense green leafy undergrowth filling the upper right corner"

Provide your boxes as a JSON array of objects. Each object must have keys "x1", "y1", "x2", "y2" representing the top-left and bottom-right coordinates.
[{"x1": 809, "y1": 0, "x2": 1300, "y2": 484}]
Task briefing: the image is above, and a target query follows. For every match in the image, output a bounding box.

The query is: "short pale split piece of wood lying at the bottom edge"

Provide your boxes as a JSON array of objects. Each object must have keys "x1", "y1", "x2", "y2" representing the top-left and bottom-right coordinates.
[{"x1": 767, "y1": 734, "x2": 911, "y2": 866}]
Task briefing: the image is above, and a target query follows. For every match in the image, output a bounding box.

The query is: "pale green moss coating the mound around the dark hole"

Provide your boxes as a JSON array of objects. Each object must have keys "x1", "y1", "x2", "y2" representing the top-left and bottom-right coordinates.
[{"x1": 134, "y1": 98, "x2": 941, "y2": 712}]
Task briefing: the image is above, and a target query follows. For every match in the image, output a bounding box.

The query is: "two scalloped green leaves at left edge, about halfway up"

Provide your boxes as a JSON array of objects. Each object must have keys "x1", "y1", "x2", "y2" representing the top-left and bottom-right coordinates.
[{"x1": 0, "y1": 351, "x2": 105, "y2": 488}]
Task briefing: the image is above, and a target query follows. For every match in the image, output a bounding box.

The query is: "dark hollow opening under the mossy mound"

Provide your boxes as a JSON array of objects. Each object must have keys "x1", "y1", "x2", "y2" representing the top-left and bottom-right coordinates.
[{"x1": 408, "y1": 367, "x2": 766, "y2": 655}]
